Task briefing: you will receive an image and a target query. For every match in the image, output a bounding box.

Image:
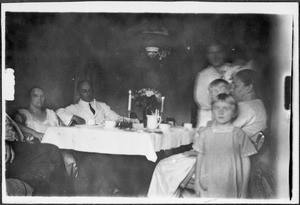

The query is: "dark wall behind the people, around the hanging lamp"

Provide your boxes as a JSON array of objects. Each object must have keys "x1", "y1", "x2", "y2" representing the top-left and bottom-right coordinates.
[{"x1": 6, "y1": 12, "x2": 273, "y2": 124}]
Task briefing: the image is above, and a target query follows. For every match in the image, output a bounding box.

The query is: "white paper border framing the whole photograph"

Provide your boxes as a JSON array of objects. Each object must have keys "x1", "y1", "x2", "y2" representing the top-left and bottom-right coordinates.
[{"x1": 1, "y1": 1, "x2": 299, "y2": 204}]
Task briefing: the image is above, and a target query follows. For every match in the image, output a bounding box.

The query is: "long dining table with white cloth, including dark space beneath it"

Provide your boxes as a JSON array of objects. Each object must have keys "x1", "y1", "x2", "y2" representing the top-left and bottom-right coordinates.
[{"x1": 42, "y1": 125, "x2": 198, "y2": 197}]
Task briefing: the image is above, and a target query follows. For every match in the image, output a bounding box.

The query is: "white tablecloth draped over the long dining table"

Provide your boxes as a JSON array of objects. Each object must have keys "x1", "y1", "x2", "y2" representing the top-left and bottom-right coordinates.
[{"x1": 42, "y1": 126, "x2": 194, "y2": 162}]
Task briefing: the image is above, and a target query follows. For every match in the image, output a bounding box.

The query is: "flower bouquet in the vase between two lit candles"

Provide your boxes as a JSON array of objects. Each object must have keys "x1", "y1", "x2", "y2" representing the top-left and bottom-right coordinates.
[{"x1": 132, "y1": 88, "x2": 162, "y2": 127}]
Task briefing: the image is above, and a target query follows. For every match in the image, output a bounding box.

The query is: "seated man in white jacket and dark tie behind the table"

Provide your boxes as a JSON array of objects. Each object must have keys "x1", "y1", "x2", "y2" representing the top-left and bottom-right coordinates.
[{"x1": 56, "y1": 80, "x2": 136, "y2": 126}]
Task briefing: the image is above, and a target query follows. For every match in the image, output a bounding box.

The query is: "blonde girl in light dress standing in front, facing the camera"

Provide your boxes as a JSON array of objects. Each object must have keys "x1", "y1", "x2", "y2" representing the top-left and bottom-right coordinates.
[{"x1": 193, "y1": 93, "x2": 256, "y2": 198}]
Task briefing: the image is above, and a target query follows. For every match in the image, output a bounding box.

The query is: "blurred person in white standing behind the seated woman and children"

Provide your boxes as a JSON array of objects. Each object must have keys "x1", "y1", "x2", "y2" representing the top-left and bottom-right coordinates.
[{"x1": 194, "y1": 43, "x2": 233, "y2": 127}]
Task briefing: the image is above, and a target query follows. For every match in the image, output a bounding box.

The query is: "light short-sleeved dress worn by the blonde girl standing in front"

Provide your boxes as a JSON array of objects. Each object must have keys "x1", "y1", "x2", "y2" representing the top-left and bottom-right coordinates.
[{"x1": 193, "y1": 126, "x2": 257, "y2": 198}]
